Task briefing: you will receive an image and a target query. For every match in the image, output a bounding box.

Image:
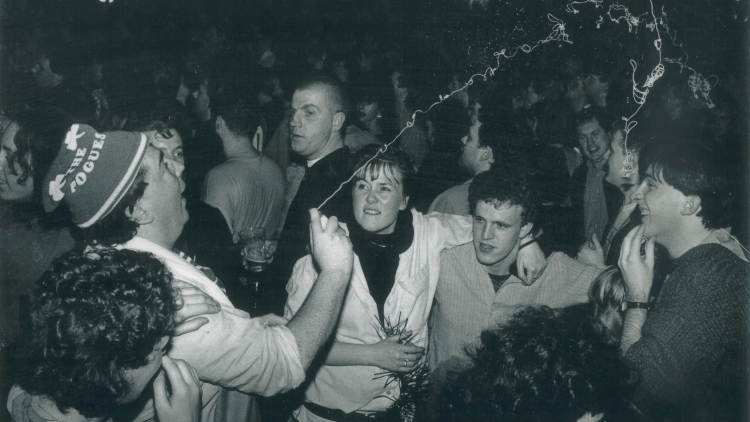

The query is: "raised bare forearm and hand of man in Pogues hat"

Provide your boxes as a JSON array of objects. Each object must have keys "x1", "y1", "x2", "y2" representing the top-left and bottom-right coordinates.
[{"x1": 287, "y1": 209, "x2": 354, "y2": 369}]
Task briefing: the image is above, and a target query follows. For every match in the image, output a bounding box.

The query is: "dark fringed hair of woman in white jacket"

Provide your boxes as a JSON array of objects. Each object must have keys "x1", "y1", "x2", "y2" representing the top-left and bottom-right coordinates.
[{"x1": 354, "y1": 144, "x2": 416, "y2": 196}]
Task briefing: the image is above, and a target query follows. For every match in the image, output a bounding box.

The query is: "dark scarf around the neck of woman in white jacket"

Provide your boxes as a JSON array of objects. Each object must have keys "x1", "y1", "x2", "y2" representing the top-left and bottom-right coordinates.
[{"x1": 349, "y1": 209, "x2": 414, "y2": 323}]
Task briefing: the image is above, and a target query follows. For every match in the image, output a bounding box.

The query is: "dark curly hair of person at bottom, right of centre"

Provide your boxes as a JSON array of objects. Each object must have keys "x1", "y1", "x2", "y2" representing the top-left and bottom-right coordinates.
[{"x1": 441, "y1": 306, "x2": 630, "y2": 422}]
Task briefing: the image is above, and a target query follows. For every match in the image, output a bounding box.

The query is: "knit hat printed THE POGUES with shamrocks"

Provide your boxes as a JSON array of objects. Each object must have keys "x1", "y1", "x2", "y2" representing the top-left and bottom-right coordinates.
[{"x1": 42, "y1": 124, "x2": 149, "y2": 228}]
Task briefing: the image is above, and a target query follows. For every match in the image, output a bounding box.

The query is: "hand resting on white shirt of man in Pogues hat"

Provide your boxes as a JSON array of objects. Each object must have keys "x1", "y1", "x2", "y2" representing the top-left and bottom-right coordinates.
[{"x1": 172, "y1": 280, "x2": 221, "y2": 337}]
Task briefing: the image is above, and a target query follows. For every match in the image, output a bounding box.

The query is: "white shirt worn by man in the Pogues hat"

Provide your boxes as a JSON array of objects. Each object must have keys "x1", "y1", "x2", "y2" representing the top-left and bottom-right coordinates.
[{"x1": 119, "y1": 237, "x2": 305, "y2": 422}]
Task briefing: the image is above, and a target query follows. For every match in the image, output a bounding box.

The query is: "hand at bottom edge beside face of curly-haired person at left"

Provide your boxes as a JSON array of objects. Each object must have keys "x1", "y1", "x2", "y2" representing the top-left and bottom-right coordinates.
[{"x1": 154, "y1": 355, "x2": 203, "y2": 422}]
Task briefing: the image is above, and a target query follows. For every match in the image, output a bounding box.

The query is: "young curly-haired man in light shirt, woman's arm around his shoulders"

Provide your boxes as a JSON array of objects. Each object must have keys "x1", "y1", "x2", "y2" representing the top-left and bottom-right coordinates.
[{"x1": 428, "y1": 162, "x2": 600, "y2": 402}]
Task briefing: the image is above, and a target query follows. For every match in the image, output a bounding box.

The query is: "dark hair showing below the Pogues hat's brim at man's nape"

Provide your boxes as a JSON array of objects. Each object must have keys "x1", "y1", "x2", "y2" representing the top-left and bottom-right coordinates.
[{"x1": 83, "y1": 167, "x2": 148, "y2": 246}]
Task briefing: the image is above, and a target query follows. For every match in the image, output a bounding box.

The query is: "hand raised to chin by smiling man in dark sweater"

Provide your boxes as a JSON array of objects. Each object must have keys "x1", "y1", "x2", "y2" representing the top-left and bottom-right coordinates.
[{"x1": 619, "y1": 224, "x2": 656, "y2": 303}]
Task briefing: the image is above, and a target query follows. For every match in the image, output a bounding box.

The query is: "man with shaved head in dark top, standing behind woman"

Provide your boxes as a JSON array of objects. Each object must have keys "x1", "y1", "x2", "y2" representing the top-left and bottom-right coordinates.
[{"x1": 271, "y1": 76, "x2": 352, "y2": 290}]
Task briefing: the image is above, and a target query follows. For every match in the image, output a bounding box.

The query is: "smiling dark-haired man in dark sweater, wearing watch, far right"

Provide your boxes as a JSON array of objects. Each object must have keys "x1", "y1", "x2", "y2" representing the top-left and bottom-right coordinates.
[{"x1": 619, "y1": 136, "x2": 750, "y2": 421}]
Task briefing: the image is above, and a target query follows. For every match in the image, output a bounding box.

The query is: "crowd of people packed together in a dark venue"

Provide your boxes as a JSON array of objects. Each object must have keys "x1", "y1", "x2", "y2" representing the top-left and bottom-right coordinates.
[{"x1": 0, "y1": 0, "x2": 750, "y2": 422}]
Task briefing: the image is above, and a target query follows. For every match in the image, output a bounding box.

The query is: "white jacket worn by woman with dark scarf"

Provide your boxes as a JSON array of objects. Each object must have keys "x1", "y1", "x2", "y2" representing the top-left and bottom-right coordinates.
[{"x1": 284, "y1": 210, "x2": 472, "y2": 422}]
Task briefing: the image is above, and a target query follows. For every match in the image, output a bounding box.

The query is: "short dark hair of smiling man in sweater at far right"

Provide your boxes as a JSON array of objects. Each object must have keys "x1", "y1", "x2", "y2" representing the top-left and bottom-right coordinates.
[{"x1": 638, "y1": 138, "x2": 734, "y2": 230}]
